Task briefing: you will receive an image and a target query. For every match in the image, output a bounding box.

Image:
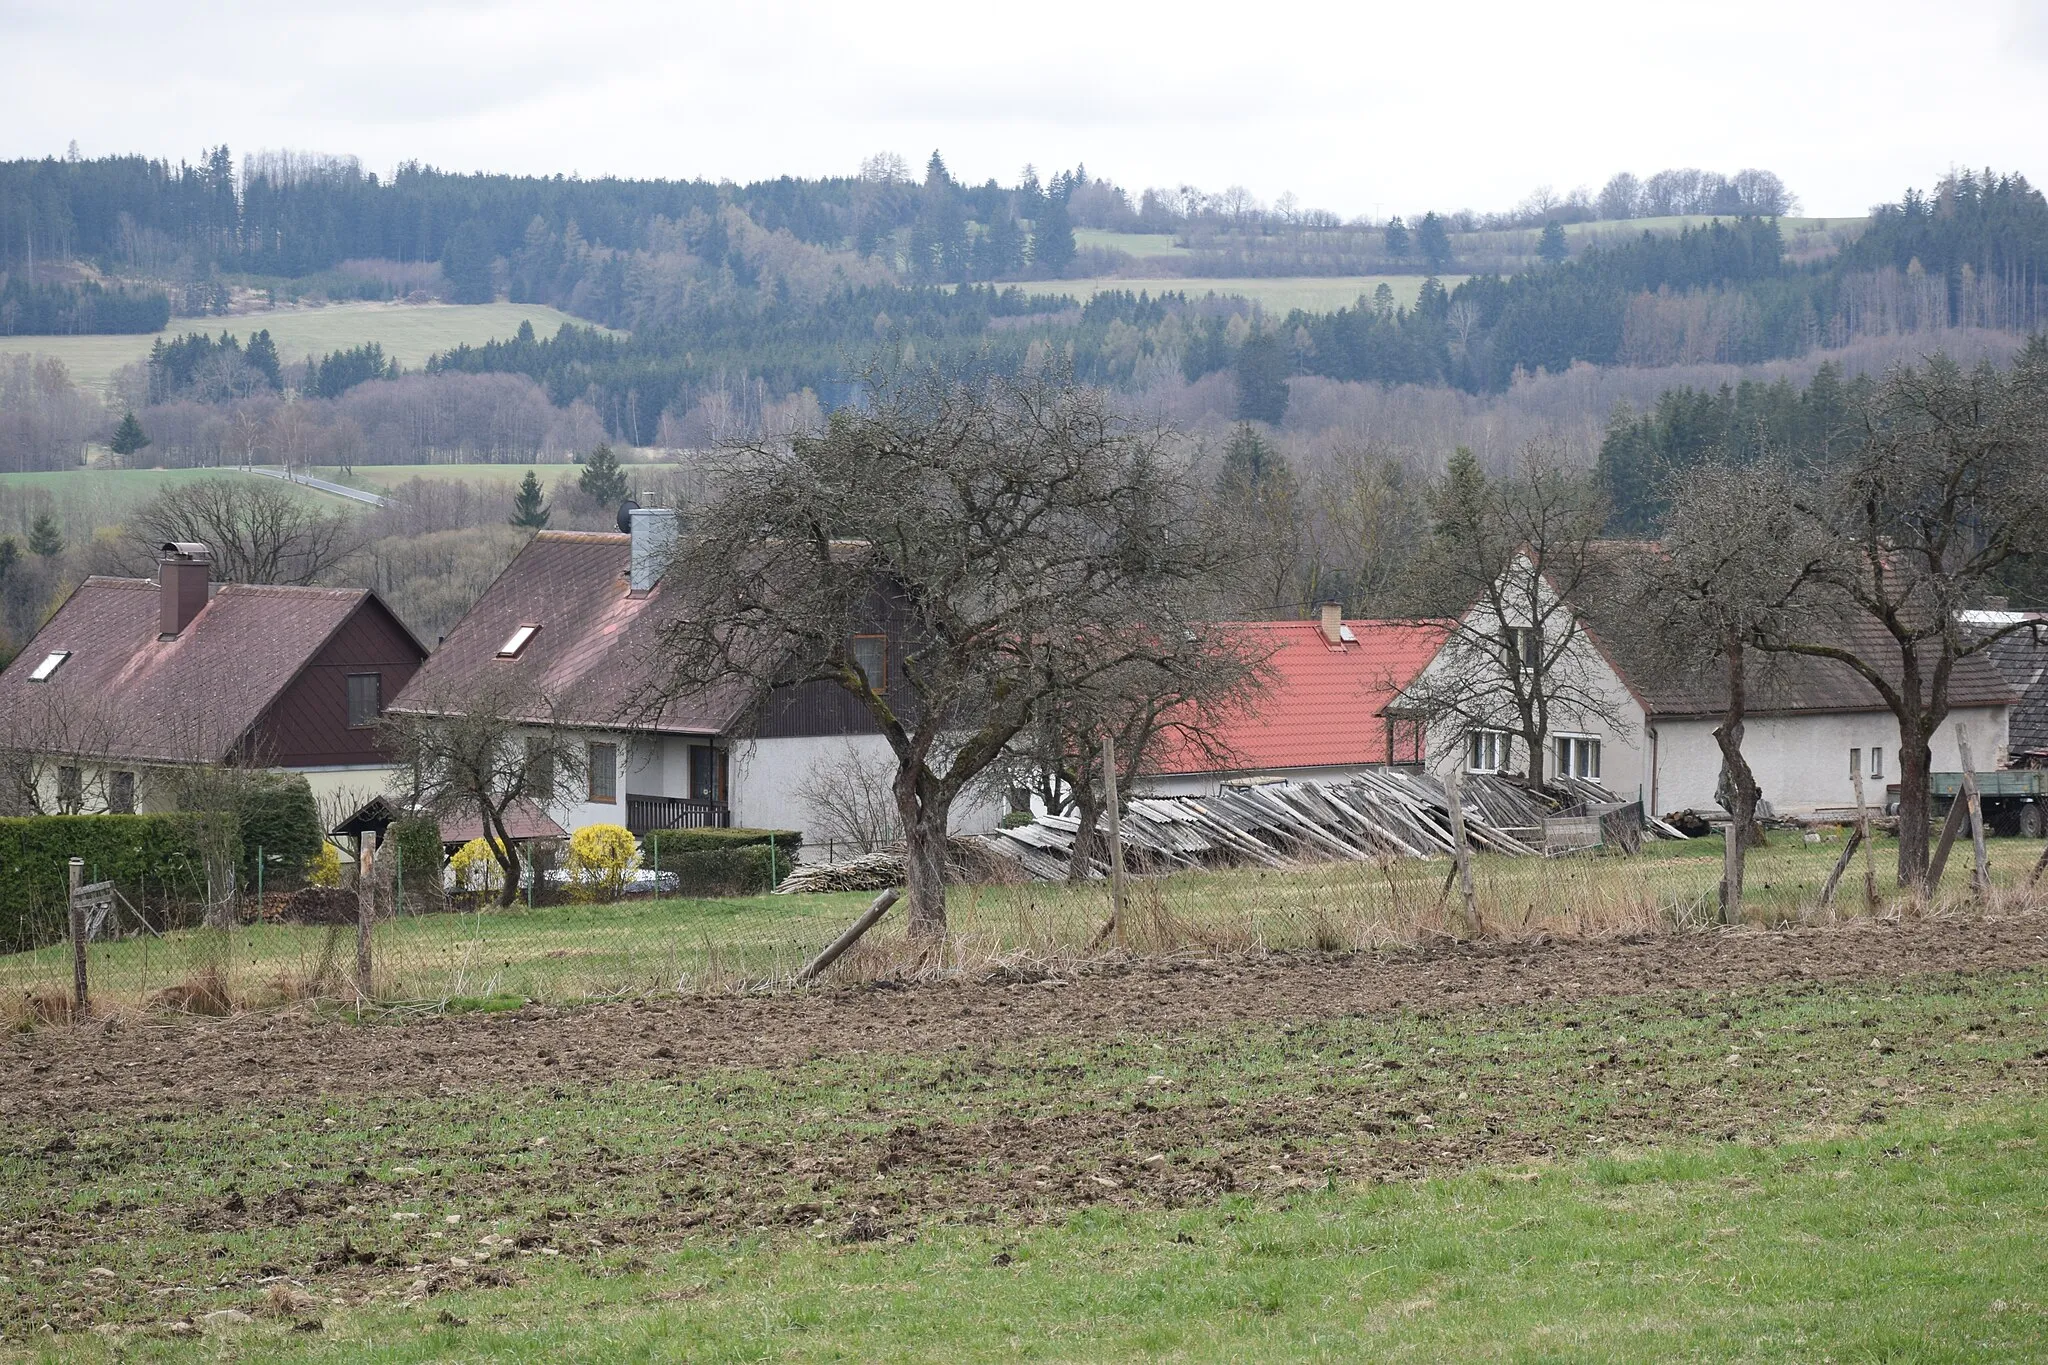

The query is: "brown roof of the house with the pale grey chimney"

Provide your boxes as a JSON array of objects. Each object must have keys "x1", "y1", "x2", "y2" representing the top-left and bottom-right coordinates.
[{"x1": 391, "y1": 530, "x2": 750, "y2": 735}]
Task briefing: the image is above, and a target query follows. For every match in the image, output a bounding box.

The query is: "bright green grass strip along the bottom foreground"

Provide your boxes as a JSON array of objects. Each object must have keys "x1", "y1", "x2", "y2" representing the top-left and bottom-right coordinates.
[{"x1": 19, "y1": 1101, "x2": 2048, "y2": 1363}]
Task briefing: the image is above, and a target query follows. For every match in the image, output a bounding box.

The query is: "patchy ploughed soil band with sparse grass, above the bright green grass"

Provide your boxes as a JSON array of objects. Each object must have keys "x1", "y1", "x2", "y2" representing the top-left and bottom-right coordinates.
[{"x1": 0, "y1": 972, "x2": 2048, "y2": 1355}]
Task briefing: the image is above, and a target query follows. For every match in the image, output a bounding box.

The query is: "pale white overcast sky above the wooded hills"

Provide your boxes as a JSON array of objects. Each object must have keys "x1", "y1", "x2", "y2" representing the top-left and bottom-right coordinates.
[{"x1": 0, "y1": 0, "x2": 2048, "y2": 217}]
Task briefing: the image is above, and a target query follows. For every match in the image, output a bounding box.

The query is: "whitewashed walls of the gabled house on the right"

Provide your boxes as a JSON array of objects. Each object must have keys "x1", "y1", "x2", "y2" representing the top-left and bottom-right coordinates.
[{"x1": 1405, "y1": 559, "x2": 2015, "y2": 817}]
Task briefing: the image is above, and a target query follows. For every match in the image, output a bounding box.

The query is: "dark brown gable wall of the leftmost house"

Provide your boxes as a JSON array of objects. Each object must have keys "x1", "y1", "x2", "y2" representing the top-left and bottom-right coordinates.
[{"x1": 256, "y1": 596, "x2": 426, "y2": 767}]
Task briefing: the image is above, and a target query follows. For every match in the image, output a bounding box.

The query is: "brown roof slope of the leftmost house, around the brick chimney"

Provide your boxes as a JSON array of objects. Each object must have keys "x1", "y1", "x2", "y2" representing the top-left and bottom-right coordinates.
[{"x1": 0, "y1": 577, "x2": 401, "y2": 763}]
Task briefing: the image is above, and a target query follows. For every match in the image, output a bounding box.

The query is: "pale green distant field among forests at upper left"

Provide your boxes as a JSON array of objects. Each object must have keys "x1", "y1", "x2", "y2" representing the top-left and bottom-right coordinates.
[{"x1": 0, "y1": 303, "x2": 606, "y2": 389}]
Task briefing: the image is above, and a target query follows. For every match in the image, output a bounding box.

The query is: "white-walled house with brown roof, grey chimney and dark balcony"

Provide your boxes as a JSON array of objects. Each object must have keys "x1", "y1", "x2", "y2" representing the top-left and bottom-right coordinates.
[{"x1": 393, "y1": 508, "x2": 999, "y2": 835}]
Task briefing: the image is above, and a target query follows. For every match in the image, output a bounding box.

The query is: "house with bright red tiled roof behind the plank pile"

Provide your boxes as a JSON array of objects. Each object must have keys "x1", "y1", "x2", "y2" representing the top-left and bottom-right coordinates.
[{"x1": 1137, "y1": 604, "x2": 1450, "y2": 796}]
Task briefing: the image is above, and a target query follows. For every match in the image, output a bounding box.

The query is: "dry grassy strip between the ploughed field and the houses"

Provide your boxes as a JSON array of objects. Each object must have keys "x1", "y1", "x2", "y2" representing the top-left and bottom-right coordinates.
[{"x1": 12, "y1": 837, "x2": 2036, "y2": 1007}]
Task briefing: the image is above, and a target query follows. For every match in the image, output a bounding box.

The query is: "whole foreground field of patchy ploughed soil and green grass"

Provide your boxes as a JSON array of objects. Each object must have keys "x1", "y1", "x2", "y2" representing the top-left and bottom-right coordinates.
[{"x1": 0, "y1": 945, "x2": 2048, "y2": 1363}]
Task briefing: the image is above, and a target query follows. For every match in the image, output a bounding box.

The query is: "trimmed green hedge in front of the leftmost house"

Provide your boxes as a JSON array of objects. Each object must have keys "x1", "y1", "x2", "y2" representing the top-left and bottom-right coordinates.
[{"x1": 0, "y1": 814, "x2": 242, "y2": 952}]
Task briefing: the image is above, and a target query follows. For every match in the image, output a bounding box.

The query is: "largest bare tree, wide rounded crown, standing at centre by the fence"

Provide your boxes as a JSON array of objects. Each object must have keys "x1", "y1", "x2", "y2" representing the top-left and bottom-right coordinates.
[{"x1": 664, "y1": 370, "x2": 1233, "y2": 935}]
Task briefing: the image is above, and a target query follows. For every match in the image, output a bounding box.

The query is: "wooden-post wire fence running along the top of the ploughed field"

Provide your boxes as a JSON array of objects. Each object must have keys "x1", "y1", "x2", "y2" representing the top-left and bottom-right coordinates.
[{"x1": 0, "y1": 839, "x2": 2038, "y2": 1019}]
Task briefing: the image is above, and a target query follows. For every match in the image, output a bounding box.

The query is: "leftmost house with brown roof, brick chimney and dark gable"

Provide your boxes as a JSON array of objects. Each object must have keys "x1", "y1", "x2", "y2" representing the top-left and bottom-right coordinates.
[{"x1": 0, "y1": 542, "x2": 426, "y2": 812}]
